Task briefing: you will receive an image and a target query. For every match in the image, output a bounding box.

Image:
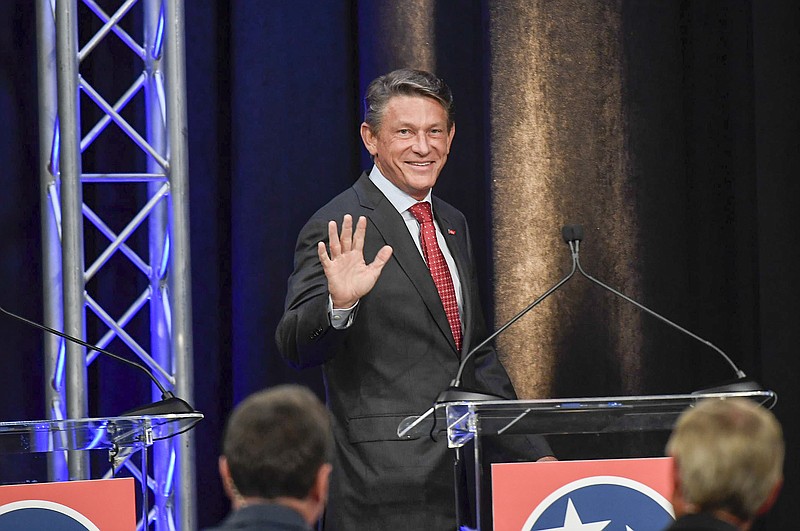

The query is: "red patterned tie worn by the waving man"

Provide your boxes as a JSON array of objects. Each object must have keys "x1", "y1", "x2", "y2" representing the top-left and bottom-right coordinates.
[{"x1": 408, "y1": 201, "x2": 461, "y2": 352}]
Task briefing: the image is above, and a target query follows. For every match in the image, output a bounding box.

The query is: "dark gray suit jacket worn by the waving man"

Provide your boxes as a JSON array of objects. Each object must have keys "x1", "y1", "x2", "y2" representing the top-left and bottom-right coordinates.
[{"x1": 276, "y1": 174, "x2": 550, "y2": 530}]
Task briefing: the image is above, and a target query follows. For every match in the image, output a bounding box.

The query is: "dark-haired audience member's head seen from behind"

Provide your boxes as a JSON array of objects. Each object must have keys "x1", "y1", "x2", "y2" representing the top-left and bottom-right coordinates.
[{"x1": 219, "y1": 385, "x2": 333, "y2": 524}]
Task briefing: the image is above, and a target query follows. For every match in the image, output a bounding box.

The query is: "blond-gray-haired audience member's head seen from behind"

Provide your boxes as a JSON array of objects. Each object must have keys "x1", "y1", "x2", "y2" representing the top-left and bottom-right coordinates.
[{"x1": 667, "y1": 398, "x2": 784, "y2": 529}]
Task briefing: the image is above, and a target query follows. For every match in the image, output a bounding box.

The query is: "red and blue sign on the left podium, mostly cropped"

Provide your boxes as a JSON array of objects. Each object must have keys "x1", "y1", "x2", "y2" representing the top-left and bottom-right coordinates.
[{"x1": 0, "y1": 478, "x2": 136, "y2": 531}]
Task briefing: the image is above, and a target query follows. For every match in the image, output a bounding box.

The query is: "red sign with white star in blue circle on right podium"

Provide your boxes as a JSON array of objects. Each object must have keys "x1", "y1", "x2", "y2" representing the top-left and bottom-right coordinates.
[{"x1": 492, "y1": 457, "x2": 674, "y2": 531}]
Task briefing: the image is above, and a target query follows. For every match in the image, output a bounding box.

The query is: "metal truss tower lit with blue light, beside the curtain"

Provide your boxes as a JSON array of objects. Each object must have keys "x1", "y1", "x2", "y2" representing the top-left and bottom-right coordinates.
[{"x1": 37, "y1": 0, "x2": 197, "y2": 531}]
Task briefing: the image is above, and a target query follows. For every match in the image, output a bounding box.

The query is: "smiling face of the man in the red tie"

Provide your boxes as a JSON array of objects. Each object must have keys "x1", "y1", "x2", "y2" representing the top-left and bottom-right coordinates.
[{"x1": 361, "y1": 96, "x2": 456, "y2": 200}]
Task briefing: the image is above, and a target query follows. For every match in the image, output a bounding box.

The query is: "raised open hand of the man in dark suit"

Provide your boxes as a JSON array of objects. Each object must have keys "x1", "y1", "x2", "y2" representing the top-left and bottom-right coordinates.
[{"x1": 317, "y1": 214, "x2": 392, "y2": 308}]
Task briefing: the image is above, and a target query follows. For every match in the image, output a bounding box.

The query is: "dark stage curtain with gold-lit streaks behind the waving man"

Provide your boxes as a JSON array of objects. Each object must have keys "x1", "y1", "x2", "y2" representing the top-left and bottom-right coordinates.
[{"x1": 0, "y1": 0, "x2": 800, "y2": 528}]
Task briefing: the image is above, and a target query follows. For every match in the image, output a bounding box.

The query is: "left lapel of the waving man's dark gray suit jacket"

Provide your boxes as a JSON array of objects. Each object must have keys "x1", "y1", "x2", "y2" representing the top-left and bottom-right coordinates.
[{"x1": 353, "y1": 177, "x2": 461, "y2": 352}]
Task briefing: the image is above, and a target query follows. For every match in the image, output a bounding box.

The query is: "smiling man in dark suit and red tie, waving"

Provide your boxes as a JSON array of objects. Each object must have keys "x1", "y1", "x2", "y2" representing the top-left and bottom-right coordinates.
[{"x1": 276, "y1": 70, "x2": 551, "y2": 531}]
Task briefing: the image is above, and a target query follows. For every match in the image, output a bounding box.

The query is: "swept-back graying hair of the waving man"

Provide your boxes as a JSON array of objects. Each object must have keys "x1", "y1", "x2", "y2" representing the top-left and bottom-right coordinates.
[{"x1": 364, "y1": 68, "x2": 453, "y2": 134}]
